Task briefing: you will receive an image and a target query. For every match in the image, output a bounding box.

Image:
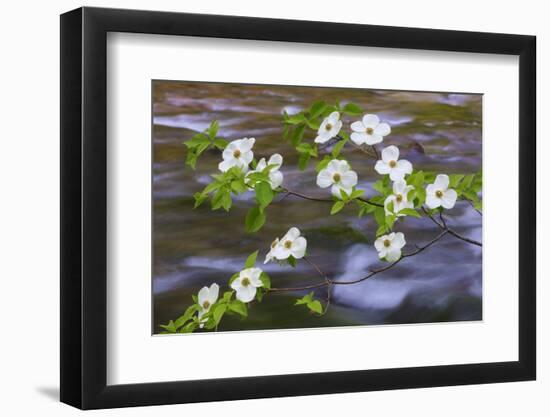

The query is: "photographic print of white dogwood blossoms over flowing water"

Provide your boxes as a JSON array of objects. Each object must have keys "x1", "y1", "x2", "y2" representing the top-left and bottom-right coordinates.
[{"x1": 152, "y1": 80, "x2": 483, "y2": 334}]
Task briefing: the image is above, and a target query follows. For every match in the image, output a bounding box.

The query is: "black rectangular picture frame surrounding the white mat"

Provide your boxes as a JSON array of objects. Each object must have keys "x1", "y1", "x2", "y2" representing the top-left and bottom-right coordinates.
[{"x1": 60, "y1": 7, "x2": 536, "y2": 409}]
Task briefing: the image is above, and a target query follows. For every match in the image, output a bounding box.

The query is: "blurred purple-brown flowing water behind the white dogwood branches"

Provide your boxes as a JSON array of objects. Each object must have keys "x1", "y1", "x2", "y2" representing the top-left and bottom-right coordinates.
[{"x1": 153, "y1": 81, "x2": 482, "y2": 332}]
